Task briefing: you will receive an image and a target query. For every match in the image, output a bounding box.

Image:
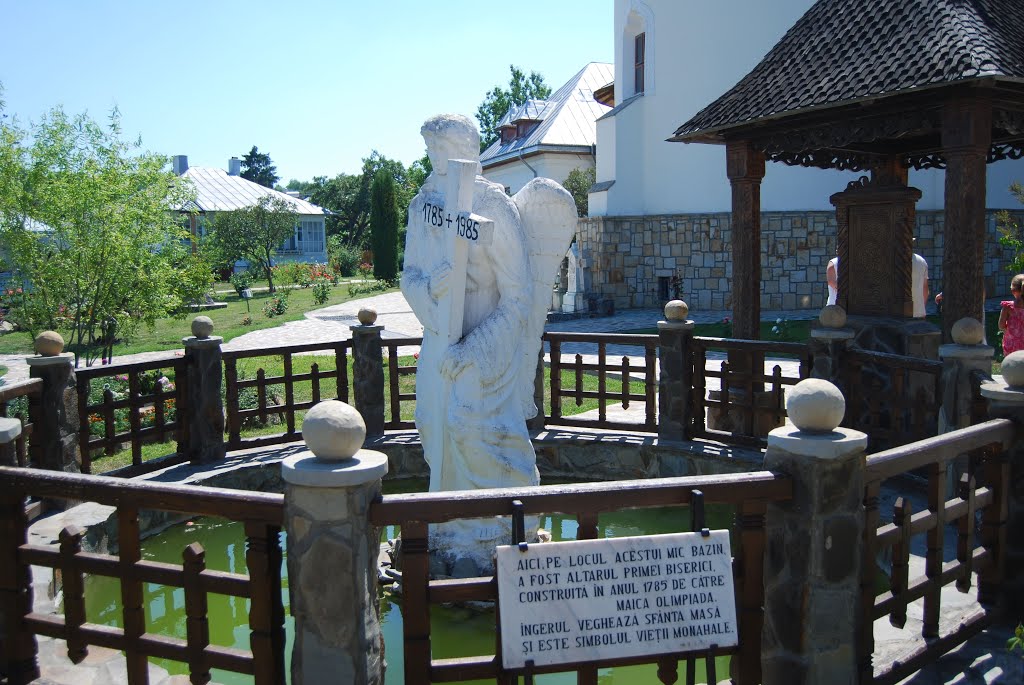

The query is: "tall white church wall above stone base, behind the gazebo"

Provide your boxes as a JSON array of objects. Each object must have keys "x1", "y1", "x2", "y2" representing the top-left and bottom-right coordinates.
[{"x1": 590, "y1": 0, "x2": 1024, "y2": 216}]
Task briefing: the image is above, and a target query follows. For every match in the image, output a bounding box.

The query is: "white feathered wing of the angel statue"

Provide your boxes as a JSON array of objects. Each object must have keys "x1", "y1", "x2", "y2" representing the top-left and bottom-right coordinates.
[{"x1": 512, "y1": 178, "x2": 577, "y2": 417}]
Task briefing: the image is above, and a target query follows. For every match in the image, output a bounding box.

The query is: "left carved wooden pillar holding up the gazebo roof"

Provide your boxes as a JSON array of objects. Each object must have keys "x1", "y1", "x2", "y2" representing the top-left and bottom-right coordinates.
[{"x1": 725, "y1": 140, "x2": 765, "y2": 340}]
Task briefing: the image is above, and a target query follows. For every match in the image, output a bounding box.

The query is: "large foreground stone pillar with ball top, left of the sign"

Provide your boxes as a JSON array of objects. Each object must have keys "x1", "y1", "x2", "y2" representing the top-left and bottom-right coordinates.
[{"x1": 281, "y1": 399, "x2": 387, "y2": 685}]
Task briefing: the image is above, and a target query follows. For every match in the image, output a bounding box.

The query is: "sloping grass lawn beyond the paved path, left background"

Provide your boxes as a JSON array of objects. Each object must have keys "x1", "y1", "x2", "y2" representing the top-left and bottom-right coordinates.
[{"x1": 0, "y1": 284, "x2": 397, "y2": 355}]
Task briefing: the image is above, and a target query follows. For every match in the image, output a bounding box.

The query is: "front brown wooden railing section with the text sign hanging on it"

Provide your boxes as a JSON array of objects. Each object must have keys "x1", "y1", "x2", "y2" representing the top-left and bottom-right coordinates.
[{"x1": 370, "y1": 471, "x2": 793, "y2": 685}]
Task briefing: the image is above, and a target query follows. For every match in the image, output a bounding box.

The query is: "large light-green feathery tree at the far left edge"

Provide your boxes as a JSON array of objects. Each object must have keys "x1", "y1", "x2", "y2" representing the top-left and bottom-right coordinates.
[{"x1": 0, "y1": 102, "x2": 213, "y2": 365}]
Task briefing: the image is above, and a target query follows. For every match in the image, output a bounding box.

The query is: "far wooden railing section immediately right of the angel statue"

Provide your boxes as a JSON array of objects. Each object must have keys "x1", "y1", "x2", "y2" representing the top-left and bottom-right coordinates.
[{"x1": 544, "y1": 333, "x2": 658, "y2": 433}]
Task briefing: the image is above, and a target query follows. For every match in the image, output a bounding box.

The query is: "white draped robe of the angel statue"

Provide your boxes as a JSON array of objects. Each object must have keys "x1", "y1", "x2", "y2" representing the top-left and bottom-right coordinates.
[{"x1": 401, "y1": 169, "x2": 540, "y2": 490}]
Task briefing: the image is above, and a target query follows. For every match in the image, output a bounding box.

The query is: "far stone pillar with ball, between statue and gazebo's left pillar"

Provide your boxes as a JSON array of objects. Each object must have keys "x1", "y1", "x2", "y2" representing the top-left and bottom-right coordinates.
[{"x1": 657, "y1": 300, "x2": 693, "y2": 440}]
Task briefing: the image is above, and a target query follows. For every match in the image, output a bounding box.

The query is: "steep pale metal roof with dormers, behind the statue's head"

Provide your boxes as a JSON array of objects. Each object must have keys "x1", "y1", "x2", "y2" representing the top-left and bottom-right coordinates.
[{"x1": 480, "y1": 61, "x2": 614, "y2": 168}]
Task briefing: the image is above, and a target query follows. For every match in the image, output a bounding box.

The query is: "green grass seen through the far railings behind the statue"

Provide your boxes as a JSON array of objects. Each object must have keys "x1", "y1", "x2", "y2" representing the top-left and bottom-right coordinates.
[{"x1": 92, "y1": 354, "x2": 643, "y2": 473}]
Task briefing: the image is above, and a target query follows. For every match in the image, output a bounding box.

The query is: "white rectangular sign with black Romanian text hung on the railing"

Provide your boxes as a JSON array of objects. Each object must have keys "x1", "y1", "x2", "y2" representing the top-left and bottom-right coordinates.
[{"x1": 498, "y1": 530, "x2": 738, "y2": 669}]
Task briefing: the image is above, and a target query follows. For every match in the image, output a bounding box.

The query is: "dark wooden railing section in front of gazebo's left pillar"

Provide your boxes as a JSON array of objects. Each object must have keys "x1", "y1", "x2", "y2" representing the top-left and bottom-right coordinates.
[{"x1": 689, "y1": 337, "x2": 811, "y2": 447}]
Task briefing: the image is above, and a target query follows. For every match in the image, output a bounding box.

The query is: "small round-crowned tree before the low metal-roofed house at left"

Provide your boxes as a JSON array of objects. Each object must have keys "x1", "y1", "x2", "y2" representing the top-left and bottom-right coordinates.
[{"x1": 208, "y1": 196, "x2": 298, "y2": 293}]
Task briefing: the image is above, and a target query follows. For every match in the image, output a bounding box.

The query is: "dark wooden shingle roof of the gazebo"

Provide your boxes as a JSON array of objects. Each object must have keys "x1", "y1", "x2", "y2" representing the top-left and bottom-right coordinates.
[{"x1": 671, "y1": 0, "x2": 1024, "y2": 142}]
